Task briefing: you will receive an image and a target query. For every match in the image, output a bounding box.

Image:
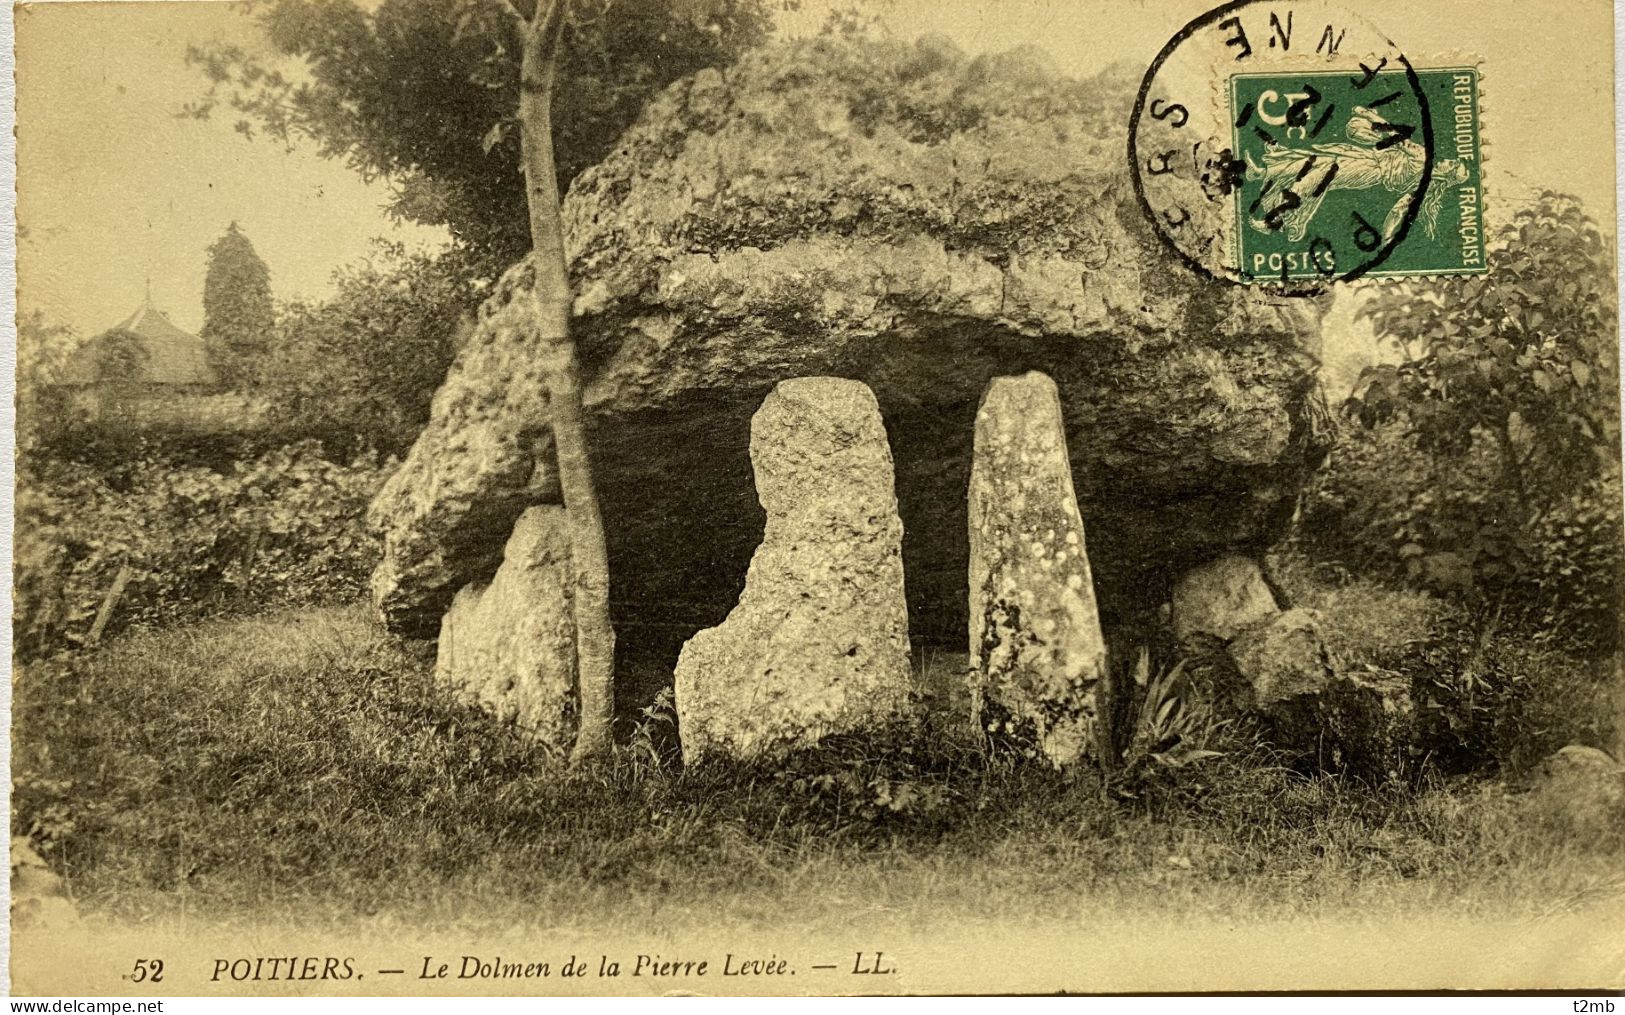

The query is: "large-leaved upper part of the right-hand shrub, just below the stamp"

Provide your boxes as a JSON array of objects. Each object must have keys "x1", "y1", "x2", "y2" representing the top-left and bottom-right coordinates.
[{"x1": 1357, "y1": 192, "x2": 1620, "y2": 467}]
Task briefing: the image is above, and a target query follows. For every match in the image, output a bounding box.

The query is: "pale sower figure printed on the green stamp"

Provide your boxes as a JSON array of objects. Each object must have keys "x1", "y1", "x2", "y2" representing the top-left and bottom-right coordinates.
[{"x1": 1246, "y1": 106, "x2": 1467, "y2": 244}]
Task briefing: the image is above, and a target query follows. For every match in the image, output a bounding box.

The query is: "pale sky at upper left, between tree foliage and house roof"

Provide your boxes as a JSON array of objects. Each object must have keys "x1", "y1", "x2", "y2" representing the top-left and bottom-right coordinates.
[{"x1": 16, "y1": 2, "x2": 444, "y2": 336}]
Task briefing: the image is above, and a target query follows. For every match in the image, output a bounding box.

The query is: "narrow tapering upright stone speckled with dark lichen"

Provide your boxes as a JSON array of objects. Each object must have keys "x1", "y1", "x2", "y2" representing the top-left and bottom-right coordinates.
[{"x1": 970, "y1": 372, "x2": 1107, "y2": 765}]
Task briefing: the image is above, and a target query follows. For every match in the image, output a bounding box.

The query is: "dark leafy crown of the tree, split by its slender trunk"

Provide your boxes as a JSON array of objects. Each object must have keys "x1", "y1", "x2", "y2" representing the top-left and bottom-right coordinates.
[{"x1": 189, "y1": 0, "x2": 769, "y2": 268}]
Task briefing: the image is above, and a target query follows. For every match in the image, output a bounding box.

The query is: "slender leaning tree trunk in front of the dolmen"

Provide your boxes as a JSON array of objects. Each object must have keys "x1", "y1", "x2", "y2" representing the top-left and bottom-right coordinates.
[{"x1": 518, "y1": 0, "x2": 614, "y2": 762}]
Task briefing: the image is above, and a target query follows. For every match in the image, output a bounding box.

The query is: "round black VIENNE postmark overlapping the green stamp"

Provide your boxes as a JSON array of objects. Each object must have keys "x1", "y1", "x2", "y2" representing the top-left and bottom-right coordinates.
[{"x1": 1128, "y1": 0, "x2": 1436, "y2": 294}]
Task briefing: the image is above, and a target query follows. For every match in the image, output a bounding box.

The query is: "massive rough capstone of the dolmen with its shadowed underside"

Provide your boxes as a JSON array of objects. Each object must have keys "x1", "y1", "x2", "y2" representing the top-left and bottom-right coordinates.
[{"x1": 372, "y1": 39, "x2": 1324, "y2": 667}]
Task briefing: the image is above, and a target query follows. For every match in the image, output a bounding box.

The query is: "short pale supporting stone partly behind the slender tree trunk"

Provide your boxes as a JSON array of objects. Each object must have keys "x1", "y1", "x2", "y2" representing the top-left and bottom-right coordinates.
[{"x1": 434, "y1": 505, "x2": 577, "y2": 754}]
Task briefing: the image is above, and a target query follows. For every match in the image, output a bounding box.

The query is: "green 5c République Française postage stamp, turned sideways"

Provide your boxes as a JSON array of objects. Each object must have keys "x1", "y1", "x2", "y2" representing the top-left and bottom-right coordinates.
[{"x1": 1229, "y1": 65, "x2": 1485, "y2": 283}]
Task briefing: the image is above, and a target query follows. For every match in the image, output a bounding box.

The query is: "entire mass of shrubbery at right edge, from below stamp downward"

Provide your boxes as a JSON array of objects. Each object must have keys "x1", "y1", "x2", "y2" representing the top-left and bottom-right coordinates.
[{"x1": 1305, "y1": 193, "x2": 1622, "y2": 646}]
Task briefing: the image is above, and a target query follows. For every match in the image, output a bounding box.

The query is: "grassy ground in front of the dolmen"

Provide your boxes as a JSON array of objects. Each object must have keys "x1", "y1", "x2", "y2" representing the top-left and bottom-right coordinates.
[{"x1": 13, "y1": 594, "x2": 1625, "y2": 926}]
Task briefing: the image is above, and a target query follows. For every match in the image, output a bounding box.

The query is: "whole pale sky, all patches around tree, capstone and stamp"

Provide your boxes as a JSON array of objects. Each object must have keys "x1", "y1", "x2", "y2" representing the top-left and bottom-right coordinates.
[{"x1": 16, "y1": 0, "x2": 1614, "y2": 344}]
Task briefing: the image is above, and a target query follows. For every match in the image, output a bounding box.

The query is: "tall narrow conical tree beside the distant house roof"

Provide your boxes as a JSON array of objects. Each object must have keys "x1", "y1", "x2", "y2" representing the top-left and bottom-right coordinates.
[{"x1": 200, "y1": 222, "x2": 275, "y2": 390}]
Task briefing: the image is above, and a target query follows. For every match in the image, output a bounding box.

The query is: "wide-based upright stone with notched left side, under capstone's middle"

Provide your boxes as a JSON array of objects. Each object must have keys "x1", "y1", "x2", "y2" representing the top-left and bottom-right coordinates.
[{"x1": 676, "y1": 377, "x2": 910, "y2": 760}]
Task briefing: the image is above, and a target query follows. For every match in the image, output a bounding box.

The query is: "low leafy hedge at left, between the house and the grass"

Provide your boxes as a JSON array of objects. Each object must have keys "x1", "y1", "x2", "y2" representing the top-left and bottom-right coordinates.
[{"x1": 15, "y1": 443, "x2": 388, "y2": 658}]
